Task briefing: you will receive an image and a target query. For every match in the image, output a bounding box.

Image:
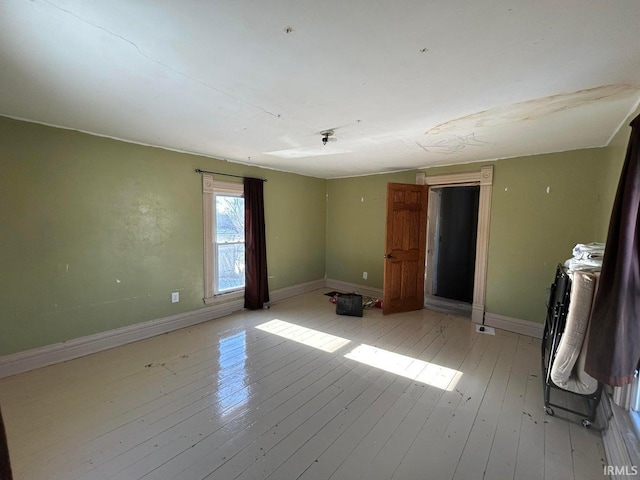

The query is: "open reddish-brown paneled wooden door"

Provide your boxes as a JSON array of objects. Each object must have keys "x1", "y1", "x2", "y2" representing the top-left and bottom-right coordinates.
[{"x1": 382, "y1": 183, "x2": 428, "y2": 314}]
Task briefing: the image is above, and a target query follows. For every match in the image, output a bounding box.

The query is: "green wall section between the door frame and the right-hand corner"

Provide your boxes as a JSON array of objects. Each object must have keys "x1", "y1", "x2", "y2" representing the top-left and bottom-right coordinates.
[{"x1": 486, "y1": 149, "x2": 606, "y2": 322}]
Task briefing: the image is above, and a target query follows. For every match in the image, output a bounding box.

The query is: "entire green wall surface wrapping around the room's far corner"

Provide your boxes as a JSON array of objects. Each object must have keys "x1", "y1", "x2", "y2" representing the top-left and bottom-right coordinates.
[{"x1": 0, "y1": 110, "x2": 629, "y2": 355}]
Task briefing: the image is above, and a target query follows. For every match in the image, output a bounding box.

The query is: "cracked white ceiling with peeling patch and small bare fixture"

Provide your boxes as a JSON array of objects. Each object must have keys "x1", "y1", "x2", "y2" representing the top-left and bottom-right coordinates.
[{"x1": 0, "y1": 0, "x2": 640, "y2": 178}]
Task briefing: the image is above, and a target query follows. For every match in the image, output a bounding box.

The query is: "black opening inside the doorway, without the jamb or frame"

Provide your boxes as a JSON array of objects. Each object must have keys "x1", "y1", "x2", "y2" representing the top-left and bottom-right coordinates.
[{"x1": 433, "y1": 186, "x2": 480, "y2": 303}]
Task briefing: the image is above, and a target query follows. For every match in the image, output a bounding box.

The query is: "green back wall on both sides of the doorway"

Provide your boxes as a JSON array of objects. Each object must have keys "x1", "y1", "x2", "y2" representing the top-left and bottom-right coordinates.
[{"x1": 327, "y1": 149, "x2": 619, "y2": 322}]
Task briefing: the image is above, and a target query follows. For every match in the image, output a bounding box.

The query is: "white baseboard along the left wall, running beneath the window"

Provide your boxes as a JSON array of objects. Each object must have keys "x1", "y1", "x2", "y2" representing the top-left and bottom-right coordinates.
[{"x1": 0, "y1": 279, "x2": 325, "y2": 378}]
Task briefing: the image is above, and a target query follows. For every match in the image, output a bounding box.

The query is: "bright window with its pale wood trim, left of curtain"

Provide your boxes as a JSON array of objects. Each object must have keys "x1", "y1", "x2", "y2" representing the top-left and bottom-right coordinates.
[{"x1": 202, "y1": 174, "x2": 245, "y2": 303}]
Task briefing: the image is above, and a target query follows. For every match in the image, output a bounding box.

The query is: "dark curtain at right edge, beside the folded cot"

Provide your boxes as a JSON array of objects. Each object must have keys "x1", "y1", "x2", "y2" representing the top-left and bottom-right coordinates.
[{"x1": 585, "y1": 115, "x2": 640, "y2": 386}]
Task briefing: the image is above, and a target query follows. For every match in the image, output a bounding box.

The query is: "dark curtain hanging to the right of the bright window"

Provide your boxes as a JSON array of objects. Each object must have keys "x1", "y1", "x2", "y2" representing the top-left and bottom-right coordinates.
[{"x1": 244, "y1": 178, "x2": 269, "y2": 310}]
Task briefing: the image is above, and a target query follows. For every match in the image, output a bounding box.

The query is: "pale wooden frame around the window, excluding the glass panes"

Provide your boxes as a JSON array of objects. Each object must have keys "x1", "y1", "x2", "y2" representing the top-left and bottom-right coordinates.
[{"x1": 202, "y1": 174, "x2": 244, "y2": 303}]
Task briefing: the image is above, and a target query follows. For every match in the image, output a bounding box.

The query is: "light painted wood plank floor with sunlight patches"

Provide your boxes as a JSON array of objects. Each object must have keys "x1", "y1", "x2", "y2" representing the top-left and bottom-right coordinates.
[{"x1": 0, "y1": 291, "x2": 606, "y2": 480}]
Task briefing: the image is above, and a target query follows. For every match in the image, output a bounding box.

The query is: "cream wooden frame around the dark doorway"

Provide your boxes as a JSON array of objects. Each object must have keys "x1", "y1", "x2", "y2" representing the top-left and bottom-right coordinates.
[{"x1": 416, "y1": 165, "x2": 493, "y2": 324}]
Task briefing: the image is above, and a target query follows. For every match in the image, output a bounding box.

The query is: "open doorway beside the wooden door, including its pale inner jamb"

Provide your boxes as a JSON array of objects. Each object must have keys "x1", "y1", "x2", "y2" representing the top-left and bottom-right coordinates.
[{"x1": 425, "y1": 185, "x2": 480, "y2": 316}]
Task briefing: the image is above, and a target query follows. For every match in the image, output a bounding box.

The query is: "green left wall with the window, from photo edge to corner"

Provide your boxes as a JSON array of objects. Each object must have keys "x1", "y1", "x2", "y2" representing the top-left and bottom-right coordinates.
[{"x1": 0, "y1": 117, "x2": 326, "y2": 355}]
